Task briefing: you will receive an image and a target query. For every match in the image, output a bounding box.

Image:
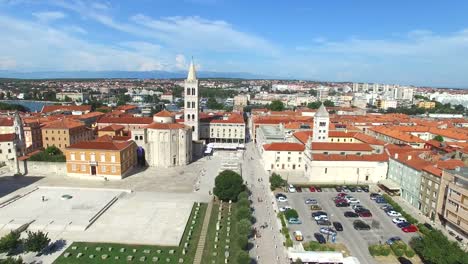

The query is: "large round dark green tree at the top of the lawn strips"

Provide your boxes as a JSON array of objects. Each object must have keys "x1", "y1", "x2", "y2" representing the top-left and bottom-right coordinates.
[{"x1": 213, "y1": 170, "x2": 245, "y2": 201}]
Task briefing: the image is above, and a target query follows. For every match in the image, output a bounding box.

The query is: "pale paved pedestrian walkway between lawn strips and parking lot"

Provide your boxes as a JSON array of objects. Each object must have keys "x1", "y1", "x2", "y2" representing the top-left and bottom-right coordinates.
[{"x1": 242, "y1": 143, "x2": 289, "y2": 264}]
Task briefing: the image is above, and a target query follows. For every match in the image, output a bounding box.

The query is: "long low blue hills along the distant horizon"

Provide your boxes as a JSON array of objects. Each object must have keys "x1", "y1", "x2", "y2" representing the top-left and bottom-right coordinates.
[{"x1": 0, "y1": 70, "x2": 274, "y2": 79}]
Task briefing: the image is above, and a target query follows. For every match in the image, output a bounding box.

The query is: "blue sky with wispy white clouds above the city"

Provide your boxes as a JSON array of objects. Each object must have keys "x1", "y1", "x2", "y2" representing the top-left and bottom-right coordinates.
[{"x1": 0, "y1": 0, "x2": 468, "y2": 87}]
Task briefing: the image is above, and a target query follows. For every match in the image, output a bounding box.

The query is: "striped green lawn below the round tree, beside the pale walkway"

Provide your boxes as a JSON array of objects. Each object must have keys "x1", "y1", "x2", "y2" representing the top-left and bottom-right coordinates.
[{"x1": 202, "y1": 202, "x2": 242, "y2": 264}]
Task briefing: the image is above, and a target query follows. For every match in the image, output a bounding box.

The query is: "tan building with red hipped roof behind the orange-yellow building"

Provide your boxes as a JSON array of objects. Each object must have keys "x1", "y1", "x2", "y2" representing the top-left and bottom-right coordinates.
[{"x1": 41, "y1": 118, "x2": 94, "y2": 152}]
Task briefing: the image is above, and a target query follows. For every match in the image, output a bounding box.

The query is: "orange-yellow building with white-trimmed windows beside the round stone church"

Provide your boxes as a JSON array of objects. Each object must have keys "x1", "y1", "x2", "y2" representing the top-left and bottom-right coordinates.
[{"x1": 65, "y1": 135, "x2": 137, "y2": 180}]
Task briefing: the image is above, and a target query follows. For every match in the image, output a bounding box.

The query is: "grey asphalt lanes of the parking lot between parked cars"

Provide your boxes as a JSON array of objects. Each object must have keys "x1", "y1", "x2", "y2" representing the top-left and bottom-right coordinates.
[{"x1": 278, "y1": 188, "x2": 416, "y2": 263}]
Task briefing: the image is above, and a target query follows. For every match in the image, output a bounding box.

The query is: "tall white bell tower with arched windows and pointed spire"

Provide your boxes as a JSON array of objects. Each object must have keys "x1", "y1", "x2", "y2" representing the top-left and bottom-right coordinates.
[{"x1": 184, "y1": 60, "x2": 200, "y2": 141}]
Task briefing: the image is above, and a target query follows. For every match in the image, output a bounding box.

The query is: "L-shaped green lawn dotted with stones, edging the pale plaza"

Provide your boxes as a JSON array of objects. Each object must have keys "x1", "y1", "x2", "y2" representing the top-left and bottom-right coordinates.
[{"x1": 54, "y1": 204, "x2": 207, "y2": 264}]
